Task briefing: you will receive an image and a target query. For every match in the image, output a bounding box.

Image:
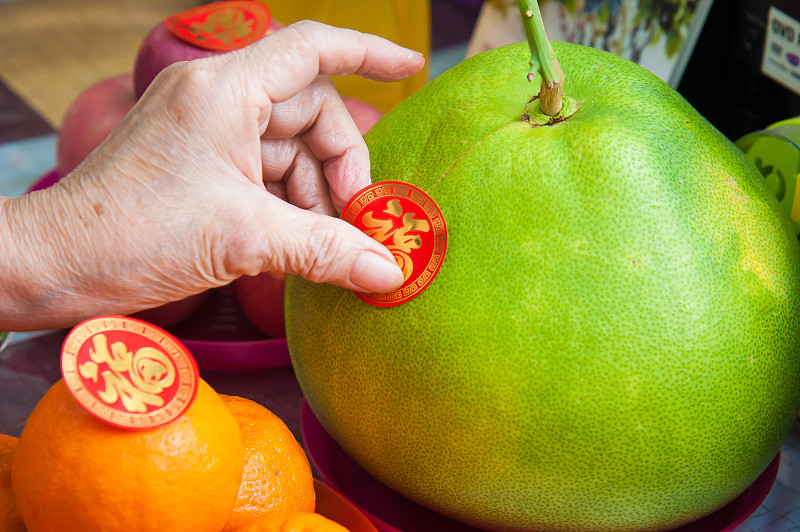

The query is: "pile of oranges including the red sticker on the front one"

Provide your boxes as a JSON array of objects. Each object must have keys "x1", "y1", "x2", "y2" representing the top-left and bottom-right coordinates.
[{"x1": 0, "y1": 317, "x2": 346, "y2": 532}]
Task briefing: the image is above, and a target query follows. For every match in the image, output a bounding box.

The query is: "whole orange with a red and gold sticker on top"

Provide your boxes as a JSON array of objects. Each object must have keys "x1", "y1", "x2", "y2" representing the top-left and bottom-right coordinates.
[{"x1": 11, "y1": 380, "x2": 244, "y2": 532}]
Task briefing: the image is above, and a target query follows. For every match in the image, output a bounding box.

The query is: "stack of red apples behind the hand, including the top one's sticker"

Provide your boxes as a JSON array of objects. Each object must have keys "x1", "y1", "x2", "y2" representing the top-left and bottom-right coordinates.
[{"x1": 47, "y1": 0, "x2": 382, "y2": 338}]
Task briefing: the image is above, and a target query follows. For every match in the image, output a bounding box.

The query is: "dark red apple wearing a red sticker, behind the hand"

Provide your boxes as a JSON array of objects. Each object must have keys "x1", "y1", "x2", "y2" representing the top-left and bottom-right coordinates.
[{"x1": 133, "y1": 20, "x2": 283, "y2": 99}]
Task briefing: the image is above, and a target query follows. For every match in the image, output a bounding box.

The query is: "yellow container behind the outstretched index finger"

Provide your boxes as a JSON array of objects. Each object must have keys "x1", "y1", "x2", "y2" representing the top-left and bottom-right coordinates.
[{"x1": 261, "y1": 0, "x2": 430, "y2": 113}]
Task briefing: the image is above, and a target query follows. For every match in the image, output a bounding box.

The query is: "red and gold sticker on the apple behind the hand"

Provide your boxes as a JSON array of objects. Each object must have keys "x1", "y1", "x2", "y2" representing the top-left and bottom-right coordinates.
[{"x1": 164, "y1": 0, "x2": 272, "y2": 52}]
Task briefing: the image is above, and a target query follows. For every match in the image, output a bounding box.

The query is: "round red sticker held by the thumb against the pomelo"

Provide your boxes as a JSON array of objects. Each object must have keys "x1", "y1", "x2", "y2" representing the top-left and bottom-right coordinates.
[{"x1": 341, "y1": 181, "x2": 447, "y2": 307}]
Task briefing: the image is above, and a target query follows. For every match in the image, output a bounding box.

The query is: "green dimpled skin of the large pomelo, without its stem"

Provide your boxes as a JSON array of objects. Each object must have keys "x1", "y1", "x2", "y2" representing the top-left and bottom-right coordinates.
[{"x1": 286, "y1": 42, "x2": 800, "y2": 532}]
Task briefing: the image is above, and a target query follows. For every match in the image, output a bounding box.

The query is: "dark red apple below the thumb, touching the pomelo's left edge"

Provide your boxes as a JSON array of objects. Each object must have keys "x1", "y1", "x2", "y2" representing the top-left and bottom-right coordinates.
[{"x1": 233, "y1": 273, "x2": 286, "y2": 338}]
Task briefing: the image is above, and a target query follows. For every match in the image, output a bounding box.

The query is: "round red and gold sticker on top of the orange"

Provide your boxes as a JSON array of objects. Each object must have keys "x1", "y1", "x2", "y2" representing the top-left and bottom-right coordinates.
[{"x1": 61, "y1": 316, "x2": 200, "y2": 430}]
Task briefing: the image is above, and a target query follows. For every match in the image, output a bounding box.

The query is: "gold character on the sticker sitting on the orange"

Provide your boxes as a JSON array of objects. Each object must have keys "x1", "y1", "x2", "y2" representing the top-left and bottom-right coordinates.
[{"x1": 78, "y1": 333, "x2": 176, "y2": 413}]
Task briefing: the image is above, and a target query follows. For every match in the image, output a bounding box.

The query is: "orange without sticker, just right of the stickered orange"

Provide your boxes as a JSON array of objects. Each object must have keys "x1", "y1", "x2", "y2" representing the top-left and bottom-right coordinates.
[{"x1": 220, "y1": 395, "x2": 315, "y2": 532}]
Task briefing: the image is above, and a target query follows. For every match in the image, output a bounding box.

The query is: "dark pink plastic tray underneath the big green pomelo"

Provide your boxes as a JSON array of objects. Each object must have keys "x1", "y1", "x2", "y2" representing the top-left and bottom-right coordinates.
[{"x1": 300, "y1": 401, "x2": 780, "y2": 532}]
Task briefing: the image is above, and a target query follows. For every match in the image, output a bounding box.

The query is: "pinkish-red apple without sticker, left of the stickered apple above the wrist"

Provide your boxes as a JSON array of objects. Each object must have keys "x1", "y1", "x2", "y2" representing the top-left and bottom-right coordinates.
[{"x1": 56, "y1": 73, "x2": 136, "y2": 176}]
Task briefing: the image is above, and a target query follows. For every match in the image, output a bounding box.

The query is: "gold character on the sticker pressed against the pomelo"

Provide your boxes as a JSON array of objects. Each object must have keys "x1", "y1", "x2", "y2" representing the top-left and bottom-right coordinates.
[{"x1": 361, "y1": 199, "x2": 431, "y2": 281}]
